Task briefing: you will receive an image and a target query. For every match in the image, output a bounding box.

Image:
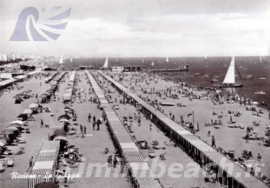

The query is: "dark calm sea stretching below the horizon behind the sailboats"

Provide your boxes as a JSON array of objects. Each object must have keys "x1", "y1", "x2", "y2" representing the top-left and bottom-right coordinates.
[{"x1": 59, "y1": 57, "x2": 270, "y2": 104}]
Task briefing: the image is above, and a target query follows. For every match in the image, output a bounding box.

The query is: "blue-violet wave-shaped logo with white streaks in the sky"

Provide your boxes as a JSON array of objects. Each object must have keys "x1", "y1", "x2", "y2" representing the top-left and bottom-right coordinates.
[{"x1": 9, "y1": 7, "x2": 71, "y2": 41}]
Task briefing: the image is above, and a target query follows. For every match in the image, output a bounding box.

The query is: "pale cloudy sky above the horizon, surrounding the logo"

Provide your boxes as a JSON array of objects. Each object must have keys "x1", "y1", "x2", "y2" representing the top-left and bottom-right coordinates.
[{"x1": 0, "y1": 0, "x2": 270, "y2": 57}]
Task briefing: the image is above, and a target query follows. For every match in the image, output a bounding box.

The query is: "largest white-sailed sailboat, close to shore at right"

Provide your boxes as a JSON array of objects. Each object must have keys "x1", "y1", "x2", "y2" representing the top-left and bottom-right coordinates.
[{"x1": 222, "y1": 57, "x2": 243, "y2": 87}]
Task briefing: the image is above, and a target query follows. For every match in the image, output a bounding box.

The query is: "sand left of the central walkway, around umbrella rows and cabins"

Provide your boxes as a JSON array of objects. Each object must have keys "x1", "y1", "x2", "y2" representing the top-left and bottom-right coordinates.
[{"x1": 0, "y1": 73, "x2": 129, "y2": 188}]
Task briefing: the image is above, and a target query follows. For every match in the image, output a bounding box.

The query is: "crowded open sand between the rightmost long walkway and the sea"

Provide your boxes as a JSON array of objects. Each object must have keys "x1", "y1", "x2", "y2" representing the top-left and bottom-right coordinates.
[{"x1": 100, "y1": 73, "x2": 270, "y2": 182}]
